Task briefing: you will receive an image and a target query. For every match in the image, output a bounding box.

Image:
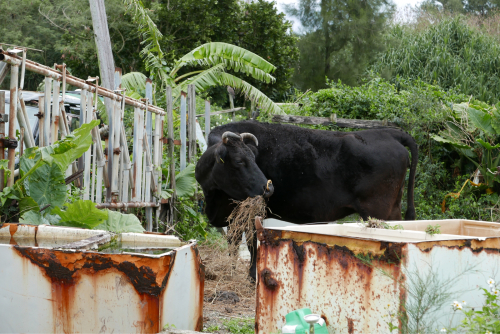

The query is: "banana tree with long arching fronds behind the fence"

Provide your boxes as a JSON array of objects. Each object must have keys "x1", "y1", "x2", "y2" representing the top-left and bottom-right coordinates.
[{"x1": 123, "y1": 0, "x2": 283, "y2": 114}]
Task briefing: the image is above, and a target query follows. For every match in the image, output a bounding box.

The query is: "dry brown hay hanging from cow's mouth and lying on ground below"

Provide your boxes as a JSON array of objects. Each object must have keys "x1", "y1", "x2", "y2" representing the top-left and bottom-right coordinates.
[{"x1": 199, "y1": 196, "x2": 266, "y2": 303}]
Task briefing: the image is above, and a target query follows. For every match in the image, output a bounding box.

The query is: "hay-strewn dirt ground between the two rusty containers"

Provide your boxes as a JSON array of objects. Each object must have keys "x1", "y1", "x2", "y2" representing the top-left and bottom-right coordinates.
[{"x1": 199, "y1": 241, "x2": 255, "y2": 334}]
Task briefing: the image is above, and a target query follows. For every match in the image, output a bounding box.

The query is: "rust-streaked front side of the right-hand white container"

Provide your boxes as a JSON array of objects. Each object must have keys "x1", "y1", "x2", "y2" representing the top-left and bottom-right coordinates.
[{"x1": 255, "y1": 229, "x2": 407, "y2": 333}]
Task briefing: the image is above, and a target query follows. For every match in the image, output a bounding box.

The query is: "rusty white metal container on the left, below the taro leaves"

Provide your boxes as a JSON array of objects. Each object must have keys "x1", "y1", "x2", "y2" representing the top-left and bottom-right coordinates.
[{"x1": 0, "y1": 224, "x2": 204, "y2": 333}]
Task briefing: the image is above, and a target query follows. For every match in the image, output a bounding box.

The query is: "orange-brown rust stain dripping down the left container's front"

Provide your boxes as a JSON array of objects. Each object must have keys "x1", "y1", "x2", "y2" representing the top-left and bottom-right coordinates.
[{"x1": 14, "y1": 246, "x2": 178, "y2": 333}]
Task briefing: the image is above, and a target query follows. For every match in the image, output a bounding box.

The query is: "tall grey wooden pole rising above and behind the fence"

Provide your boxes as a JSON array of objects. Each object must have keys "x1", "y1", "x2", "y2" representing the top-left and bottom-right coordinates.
[{"x1": 89, "y1": 0, "x2": 115, "y2": 203}]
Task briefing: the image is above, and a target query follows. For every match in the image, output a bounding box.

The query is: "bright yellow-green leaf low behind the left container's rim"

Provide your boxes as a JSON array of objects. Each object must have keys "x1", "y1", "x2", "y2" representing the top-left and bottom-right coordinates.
[{"x1": 52, "y1": 200, "x2": 108, "y2": 229}]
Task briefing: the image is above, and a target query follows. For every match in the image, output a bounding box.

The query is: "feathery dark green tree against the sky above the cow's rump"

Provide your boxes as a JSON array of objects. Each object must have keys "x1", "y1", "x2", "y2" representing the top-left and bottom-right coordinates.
[{"x1": 287, "y1": 0, "x2": 393, "y2": 90}]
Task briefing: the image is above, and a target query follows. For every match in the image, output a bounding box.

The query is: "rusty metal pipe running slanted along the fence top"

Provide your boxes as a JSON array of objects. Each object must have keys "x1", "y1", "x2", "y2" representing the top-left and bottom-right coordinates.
[{"x1": 0, "y1": 51, "x2": 165, "y2": 115}]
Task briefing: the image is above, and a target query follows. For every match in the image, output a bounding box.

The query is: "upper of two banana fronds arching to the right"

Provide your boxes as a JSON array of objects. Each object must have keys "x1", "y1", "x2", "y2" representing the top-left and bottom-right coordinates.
[{"x1": 171, "y1": 42, "x2": 276, "y2": 83}]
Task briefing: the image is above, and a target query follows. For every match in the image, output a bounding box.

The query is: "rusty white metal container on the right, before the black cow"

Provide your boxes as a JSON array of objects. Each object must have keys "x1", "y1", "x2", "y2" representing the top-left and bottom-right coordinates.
[{"x1": 255, "y1": 219, "x2": 500, "y2": 334}]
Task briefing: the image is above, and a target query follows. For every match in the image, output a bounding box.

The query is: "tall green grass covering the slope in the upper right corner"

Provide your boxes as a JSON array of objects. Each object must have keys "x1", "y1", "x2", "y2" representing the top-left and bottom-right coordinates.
[{"x1": 372, "y1": 11, "x2": 500, "y2": 103}]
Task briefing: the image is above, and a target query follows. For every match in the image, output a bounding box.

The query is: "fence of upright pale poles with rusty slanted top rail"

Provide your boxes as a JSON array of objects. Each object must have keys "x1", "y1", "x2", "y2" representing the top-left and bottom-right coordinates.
[{"x1": 0, "y1": 50, "x2": 172, "y2": 231}]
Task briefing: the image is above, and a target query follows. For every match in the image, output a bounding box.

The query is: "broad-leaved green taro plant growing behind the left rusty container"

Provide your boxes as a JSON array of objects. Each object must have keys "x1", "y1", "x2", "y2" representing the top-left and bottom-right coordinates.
[{"x1": 0, "y1": 121, "x2": 144, "y2": 232}]
